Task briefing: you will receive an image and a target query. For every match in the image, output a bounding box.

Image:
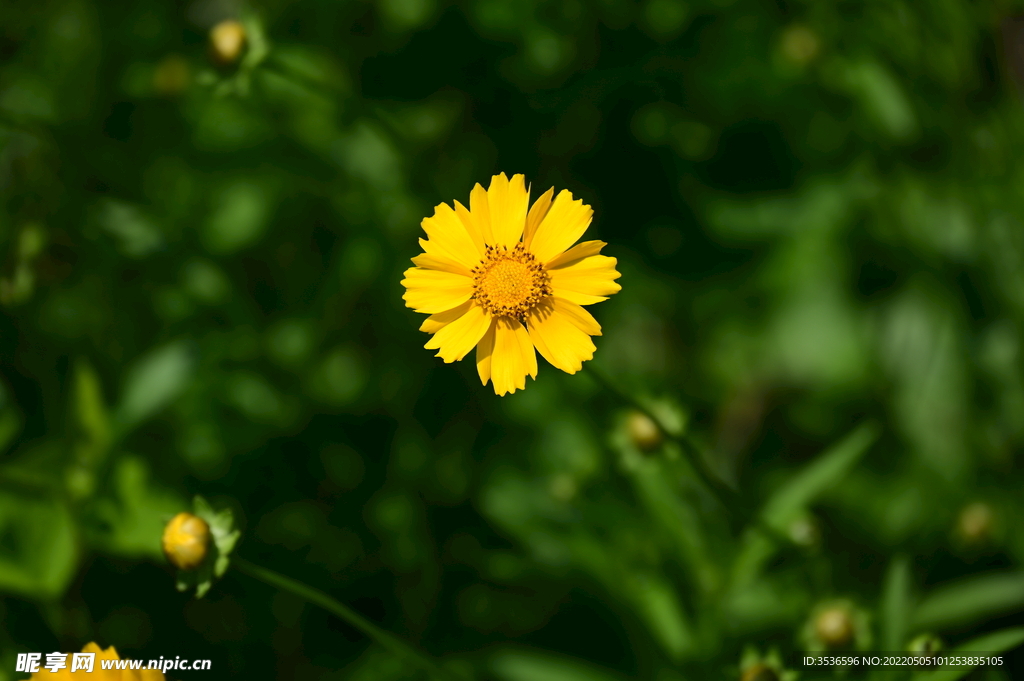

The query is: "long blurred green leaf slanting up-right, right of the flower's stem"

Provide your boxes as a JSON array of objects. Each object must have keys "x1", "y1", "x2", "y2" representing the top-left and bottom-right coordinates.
[{"x1": 763, "y1": 424, "x2": 878, "y2": 531}]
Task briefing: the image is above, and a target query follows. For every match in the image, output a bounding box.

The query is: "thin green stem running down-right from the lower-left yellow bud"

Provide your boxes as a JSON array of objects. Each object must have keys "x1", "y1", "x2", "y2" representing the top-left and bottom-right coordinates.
[{"x1": 231, "y1": 558, "x2": 467, "y2": 681}]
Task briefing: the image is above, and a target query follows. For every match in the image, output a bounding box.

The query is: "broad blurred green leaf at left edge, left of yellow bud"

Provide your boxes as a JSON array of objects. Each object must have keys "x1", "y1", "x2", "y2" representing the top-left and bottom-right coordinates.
[{"x1": 0, "y1": 493, "x2": 78, "y2": 599}]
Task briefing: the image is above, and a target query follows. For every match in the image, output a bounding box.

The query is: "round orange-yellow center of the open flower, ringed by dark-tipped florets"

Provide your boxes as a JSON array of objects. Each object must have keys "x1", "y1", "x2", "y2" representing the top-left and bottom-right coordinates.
[{"x1": 473, "y1": 243, "x2": 551, "y2": 322}]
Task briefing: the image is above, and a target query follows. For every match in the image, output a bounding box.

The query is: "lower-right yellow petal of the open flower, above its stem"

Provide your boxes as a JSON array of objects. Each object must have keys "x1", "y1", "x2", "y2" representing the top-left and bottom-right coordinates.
[{"x1": 526, "y1": 298, "x2": 600, "y2": 374}]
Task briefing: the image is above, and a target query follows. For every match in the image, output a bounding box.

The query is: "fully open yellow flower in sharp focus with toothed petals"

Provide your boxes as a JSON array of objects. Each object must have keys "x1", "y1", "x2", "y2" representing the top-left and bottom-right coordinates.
[{"x1": 401, "y1": 173, "x2": 622, "y2": 395}]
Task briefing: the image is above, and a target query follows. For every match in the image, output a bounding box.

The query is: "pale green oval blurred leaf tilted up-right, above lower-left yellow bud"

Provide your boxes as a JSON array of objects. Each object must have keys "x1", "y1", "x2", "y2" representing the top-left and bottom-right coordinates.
[{"x1": 117, "y1": 341, "x2": 194, "y2": 430}]
